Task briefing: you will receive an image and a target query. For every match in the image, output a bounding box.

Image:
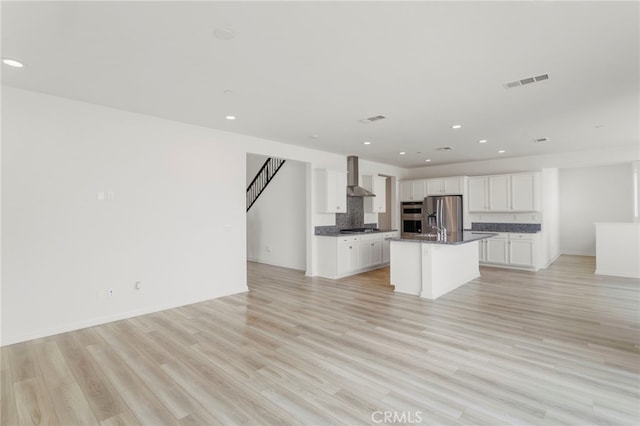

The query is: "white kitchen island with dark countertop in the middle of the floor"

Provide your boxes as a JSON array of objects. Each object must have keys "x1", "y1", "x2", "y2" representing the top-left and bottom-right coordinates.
[{"x1": 389, "y1": 231, "x2": 495, "y2": 299}]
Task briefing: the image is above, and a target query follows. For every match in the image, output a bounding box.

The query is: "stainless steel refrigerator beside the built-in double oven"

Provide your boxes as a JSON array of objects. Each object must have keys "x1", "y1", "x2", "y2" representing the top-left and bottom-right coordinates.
[{"x1": 422, "y1": 195, "x2": 463, "y2": 234}]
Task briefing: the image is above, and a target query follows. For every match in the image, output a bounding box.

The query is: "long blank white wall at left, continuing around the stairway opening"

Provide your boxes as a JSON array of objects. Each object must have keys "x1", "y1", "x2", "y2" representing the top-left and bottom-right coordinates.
[{"x1": 0, "y1": 86, "x2": 404, "y2": 345}]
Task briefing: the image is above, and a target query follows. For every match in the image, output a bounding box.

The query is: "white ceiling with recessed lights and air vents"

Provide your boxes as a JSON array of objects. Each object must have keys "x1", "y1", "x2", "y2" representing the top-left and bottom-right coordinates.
[{"x1": 2, "y1": 1, "x2": 640, "y2": 167}]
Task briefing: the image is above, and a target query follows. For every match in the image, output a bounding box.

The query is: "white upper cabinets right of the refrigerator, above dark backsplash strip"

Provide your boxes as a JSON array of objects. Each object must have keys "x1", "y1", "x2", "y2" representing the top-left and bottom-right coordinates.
[{"x1": 468, "y1": 173, "x2": 540, "y2": 212}]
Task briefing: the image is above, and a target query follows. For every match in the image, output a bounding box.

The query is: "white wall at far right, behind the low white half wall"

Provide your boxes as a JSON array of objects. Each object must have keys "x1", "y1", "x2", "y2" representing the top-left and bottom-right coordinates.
[{"x1": 559, "y1": 163, "x2": 633, "y2": 256}]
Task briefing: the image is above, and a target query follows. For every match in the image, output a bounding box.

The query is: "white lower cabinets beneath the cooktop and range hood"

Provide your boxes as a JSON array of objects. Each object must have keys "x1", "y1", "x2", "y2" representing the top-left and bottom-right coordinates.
[{"x1": 318, "y1": 231, "x2": 400, "y2": 278}]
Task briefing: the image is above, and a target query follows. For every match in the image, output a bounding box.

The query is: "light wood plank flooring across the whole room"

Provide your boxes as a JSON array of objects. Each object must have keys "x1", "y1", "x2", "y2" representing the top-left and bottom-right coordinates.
[{"x1": 0, "y1": 256, "x2": 640, "y2": 425}]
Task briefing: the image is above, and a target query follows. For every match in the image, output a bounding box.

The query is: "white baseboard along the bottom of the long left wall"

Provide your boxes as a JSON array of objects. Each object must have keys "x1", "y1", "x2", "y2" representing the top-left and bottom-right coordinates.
[{"x1": 0, "y1": 287, "x2": 249, "y2": 346}]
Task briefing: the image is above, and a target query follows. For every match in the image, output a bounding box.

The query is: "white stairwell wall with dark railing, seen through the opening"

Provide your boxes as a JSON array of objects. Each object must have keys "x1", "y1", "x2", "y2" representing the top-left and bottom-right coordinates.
[{"x1": 246, "y1": 154, "x2": 306, "y2": 270}]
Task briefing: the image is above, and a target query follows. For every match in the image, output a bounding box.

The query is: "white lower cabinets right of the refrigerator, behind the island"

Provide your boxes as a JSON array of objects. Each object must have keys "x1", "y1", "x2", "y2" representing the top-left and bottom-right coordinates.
[{"x1": 478, "y1": 232, "x2": 541, "y2": 270}]
